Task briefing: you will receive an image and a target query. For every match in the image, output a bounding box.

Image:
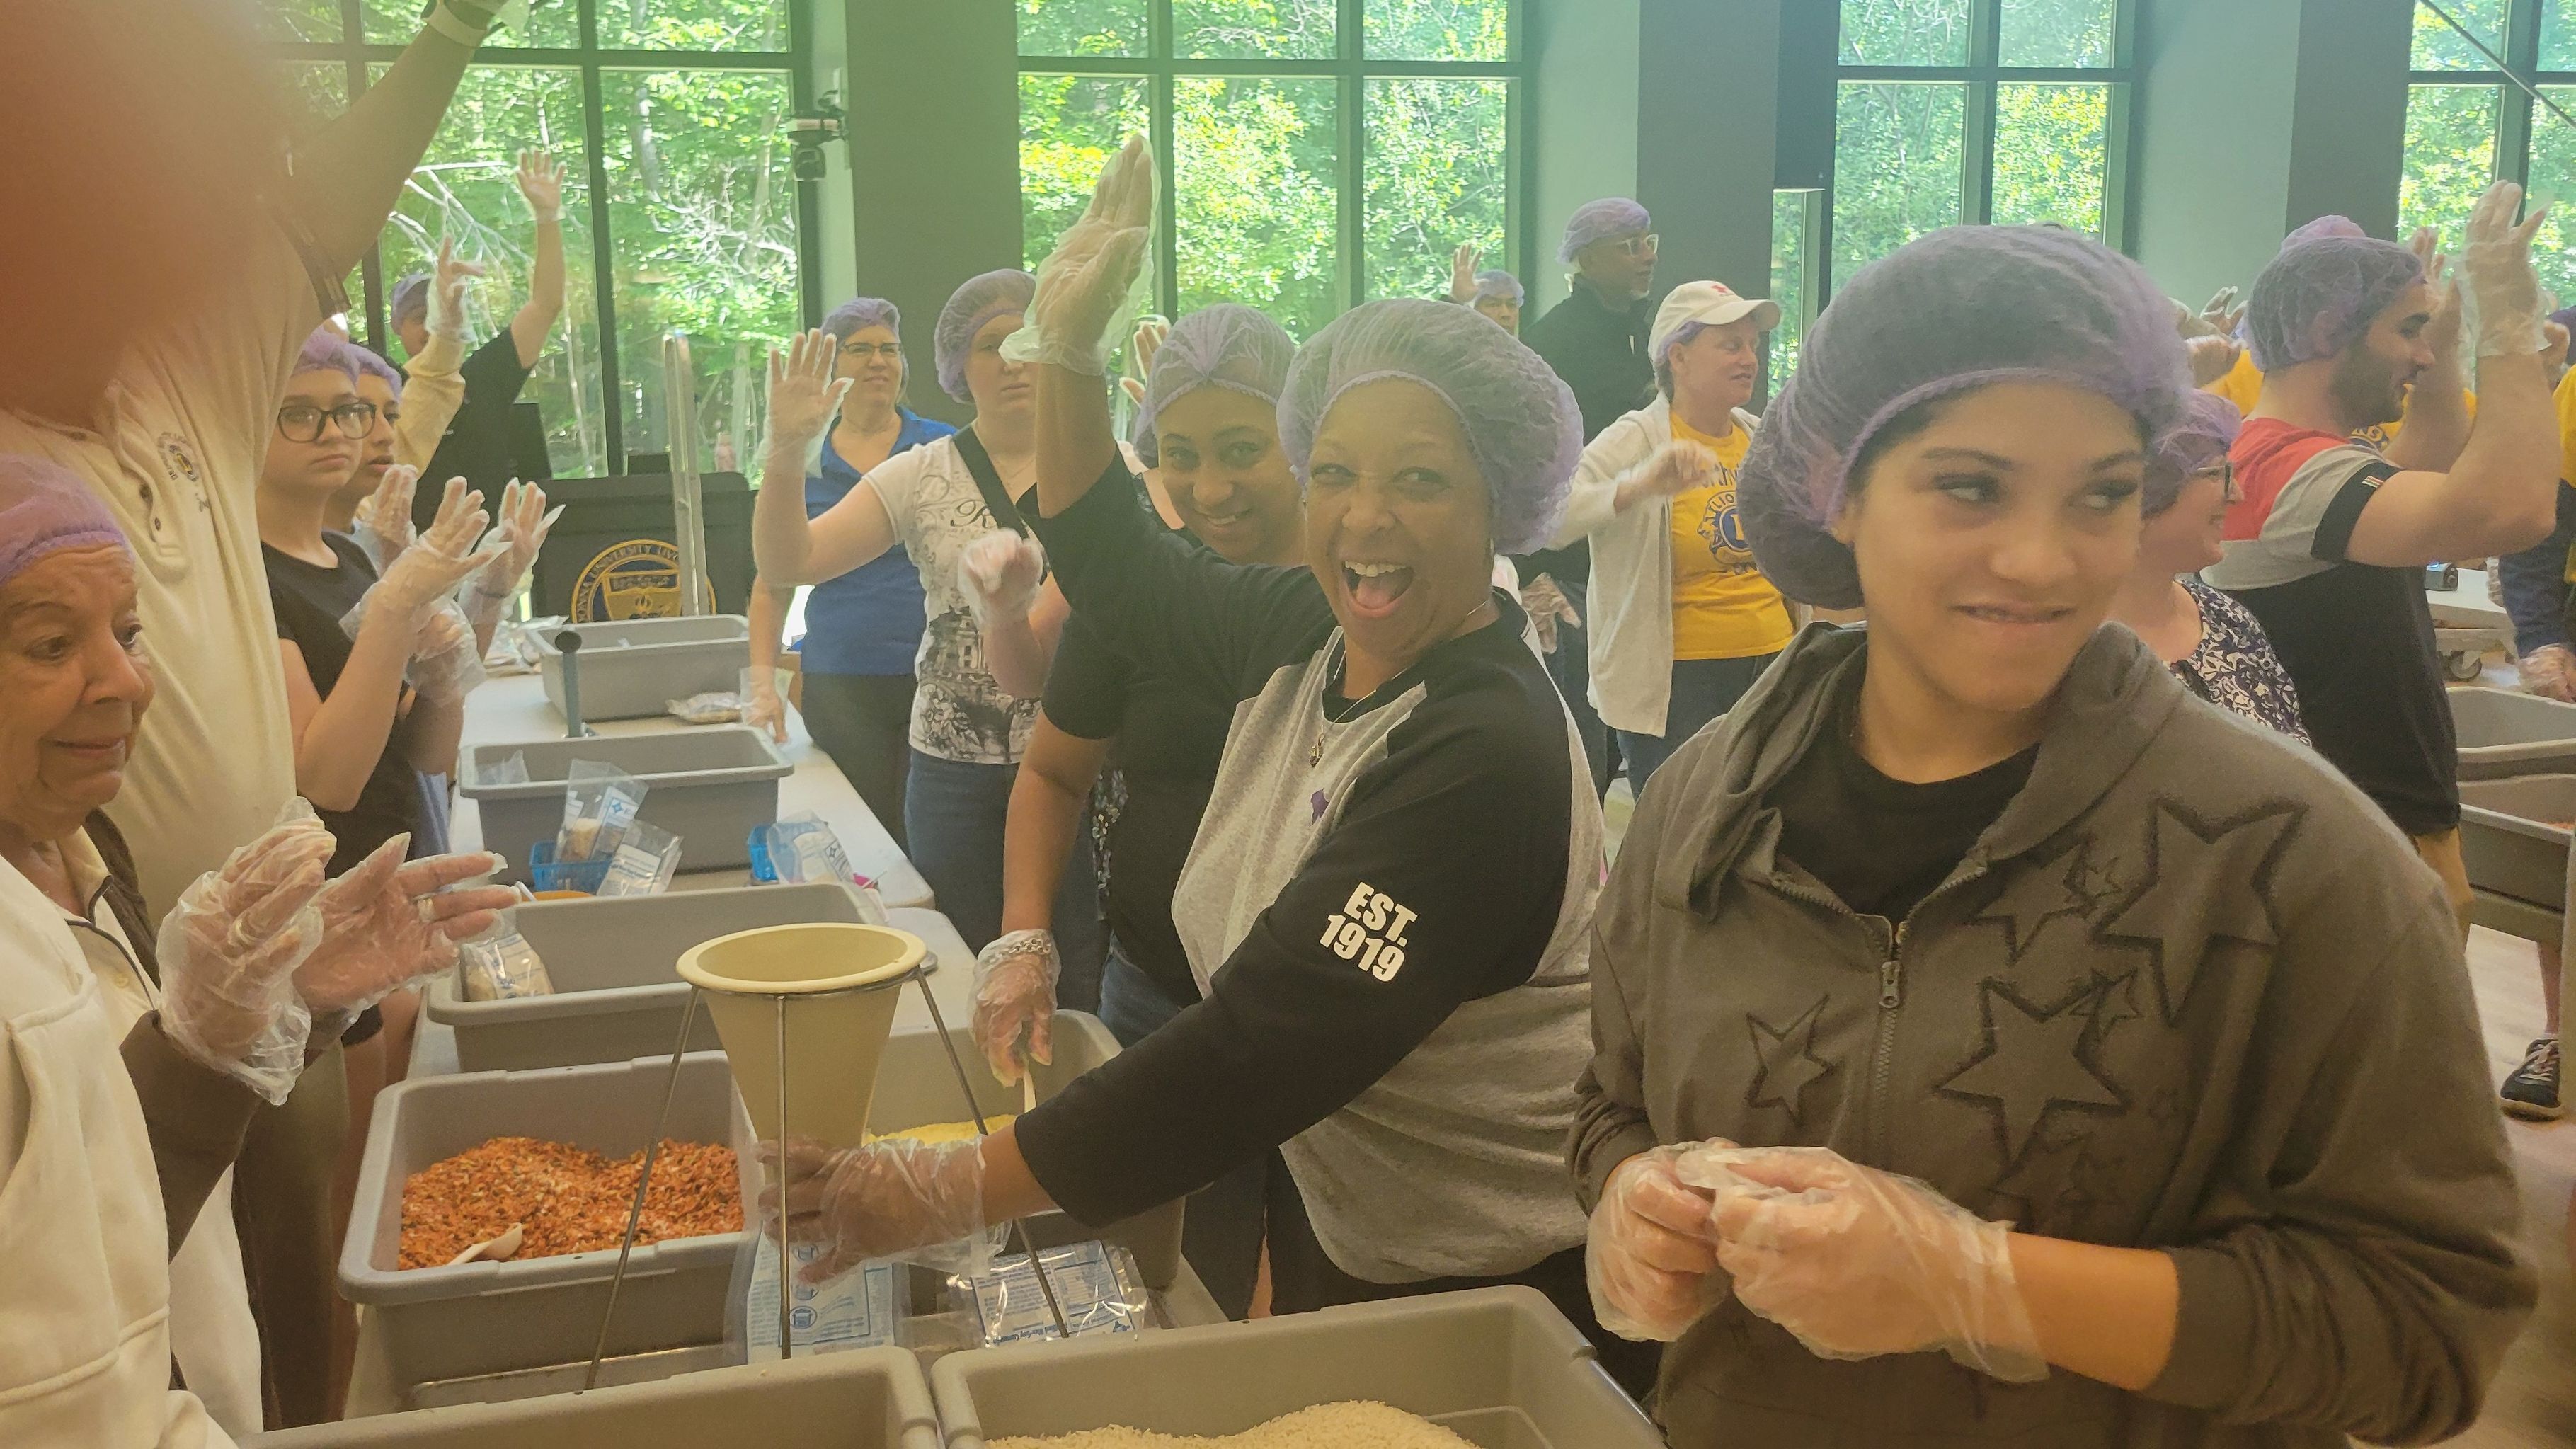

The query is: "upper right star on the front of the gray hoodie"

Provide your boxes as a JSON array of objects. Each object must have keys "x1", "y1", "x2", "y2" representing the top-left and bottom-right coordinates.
[{"x1": 2097, "y1": 798, "x2": 2306, "y2": 1027}]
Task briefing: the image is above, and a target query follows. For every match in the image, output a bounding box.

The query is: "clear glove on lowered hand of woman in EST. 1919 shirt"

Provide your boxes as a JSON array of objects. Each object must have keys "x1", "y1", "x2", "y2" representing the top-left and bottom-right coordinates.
[{"x1": 760, "y1": 1138, "x2": 984, "y2": 1282}]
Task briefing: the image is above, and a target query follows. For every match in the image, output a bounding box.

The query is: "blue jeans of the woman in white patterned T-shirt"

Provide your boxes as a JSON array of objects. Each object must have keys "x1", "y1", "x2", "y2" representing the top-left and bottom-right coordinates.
[{"x1": 904, "y1": 749, "x2": 1108, "y2": 1012}]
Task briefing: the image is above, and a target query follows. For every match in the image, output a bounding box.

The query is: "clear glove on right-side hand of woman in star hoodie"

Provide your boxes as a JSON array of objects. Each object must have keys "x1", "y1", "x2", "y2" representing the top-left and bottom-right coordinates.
[{"x1": 1674, "y1": 1148, "x2": 2048, "y2": 1382}]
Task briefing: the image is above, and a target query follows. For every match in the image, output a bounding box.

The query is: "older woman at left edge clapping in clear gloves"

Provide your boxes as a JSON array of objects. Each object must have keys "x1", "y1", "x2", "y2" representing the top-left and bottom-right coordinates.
[{"x1": 0, "y1": 456, "x2": 510, "y2": 1449}]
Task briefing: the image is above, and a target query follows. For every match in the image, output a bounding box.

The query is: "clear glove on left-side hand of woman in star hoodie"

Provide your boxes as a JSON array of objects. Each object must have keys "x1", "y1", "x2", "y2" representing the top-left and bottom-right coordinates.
[{"x1": 1584, "y1": 1142, "x2": 1731, "y2": 1344}]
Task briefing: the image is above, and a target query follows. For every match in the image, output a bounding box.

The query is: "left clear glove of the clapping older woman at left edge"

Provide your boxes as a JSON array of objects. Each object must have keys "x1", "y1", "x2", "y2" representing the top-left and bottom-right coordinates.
[{"x1": 154, "y1": 801, "x2": 338, "y2": 1104}]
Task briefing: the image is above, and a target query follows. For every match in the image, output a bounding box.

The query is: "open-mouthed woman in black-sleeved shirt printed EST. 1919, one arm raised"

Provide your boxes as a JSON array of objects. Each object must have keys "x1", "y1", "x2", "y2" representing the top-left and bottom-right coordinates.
[{"x1": 762, "y1": 139, "x2": 1644, "y2": 1390}]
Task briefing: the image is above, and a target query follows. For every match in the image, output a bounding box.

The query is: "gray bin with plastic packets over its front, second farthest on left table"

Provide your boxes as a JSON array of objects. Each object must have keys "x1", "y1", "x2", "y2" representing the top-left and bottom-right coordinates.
[{"x1": 459, "y1": 726, "x2": 796, "y2": 883}]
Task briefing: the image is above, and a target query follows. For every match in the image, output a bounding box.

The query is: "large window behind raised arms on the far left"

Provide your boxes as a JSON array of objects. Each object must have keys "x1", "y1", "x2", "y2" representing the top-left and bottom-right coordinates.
[{"x1": 263, "y1": 0, "x2": 803, "y2": 476}]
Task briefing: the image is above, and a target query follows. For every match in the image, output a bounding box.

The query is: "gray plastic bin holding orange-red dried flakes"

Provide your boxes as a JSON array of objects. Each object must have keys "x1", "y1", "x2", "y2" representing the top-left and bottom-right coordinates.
[{"x1": 340, "y1": 1053, "x2": 760, "y2": 1403}]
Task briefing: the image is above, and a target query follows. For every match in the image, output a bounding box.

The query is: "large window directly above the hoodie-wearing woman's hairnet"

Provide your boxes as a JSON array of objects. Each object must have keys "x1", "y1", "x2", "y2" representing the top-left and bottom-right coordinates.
[{"x1": 1833, "y1": 0, "x2": 2133, "y2": 304}]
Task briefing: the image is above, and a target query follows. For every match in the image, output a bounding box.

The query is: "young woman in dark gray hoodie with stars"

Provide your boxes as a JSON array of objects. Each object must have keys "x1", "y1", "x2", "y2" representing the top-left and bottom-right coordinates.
[{"x1": 1572, "y1": 227, "x2": 2535, "y2": 1449}]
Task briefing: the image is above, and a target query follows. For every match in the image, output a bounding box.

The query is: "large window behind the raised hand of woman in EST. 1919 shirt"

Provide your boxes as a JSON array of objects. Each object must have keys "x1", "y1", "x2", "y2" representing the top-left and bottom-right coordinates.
[{"x1": 1015, "y1": 0, "x2": 1528, "y2": 337}]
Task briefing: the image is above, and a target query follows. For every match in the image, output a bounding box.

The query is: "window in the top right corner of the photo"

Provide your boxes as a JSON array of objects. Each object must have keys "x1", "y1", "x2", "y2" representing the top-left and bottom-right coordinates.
[{"x1": 2398, "y1": 0, "x2": 2576, "y2": 299}]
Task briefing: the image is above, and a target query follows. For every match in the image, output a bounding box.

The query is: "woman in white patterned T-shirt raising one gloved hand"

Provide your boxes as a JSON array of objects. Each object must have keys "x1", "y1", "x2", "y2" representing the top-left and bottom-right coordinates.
[{"x1": 752, "y1": 270, "x2": 1100, "y2": 1009}]
